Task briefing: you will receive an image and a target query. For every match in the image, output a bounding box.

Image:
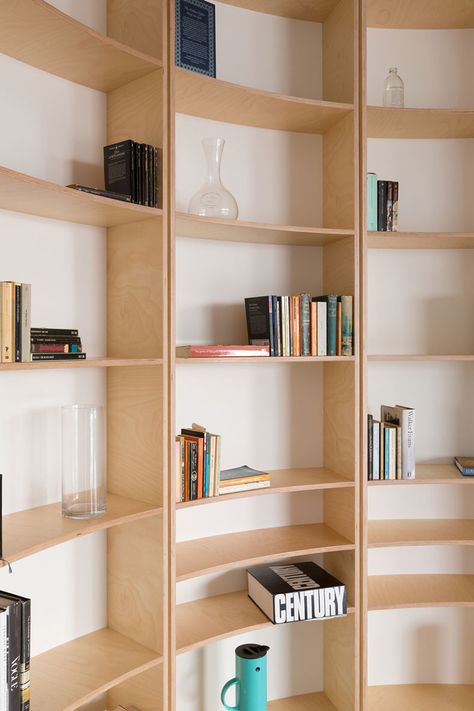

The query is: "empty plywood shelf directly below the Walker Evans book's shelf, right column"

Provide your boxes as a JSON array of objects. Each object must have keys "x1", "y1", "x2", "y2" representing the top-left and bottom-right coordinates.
[{"x1": 368, "y1": 518, "x2": 474, "y2": 548}]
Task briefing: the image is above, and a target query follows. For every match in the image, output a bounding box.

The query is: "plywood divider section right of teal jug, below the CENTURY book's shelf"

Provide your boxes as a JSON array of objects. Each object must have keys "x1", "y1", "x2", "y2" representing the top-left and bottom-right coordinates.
[{"x1": 324, "y1": 615, "x2": 356, "y2": 711}]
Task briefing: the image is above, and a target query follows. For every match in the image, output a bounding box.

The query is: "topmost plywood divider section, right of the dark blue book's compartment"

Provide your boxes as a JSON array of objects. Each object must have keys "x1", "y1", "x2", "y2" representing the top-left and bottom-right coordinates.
[{"x1": 323, "y1": 0, "x2": 357, "y2": 104}]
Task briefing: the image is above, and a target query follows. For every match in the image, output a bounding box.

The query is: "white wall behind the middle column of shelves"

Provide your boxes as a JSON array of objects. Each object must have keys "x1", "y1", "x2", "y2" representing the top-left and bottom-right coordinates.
[{"x1": 176, "y1": 4, "x2": 323, "y2": 711}]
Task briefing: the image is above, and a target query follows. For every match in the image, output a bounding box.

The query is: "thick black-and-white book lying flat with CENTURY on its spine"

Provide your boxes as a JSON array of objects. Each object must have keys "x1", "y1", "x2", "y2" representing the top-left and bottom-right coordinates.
[{"x1": 247, "y1": 562, "x2": 347, "y2": 625}]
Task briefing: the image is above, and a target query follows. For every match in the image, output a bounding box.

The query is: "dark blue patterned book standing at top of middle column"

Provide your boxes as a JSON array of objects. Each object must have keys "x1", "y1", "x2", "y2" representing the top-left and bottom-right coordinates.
[{"x1": 176, "y1": 0, "x2": 216, "y2": 77}]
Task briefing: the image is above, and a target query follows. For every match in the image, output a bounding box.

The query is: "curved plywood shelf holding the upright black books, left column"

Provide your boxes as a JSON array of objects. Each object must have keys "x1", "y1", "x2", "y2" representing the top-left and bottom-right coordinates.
[{"x1": 0, "y1": 167, "x2": 162, "y2": 227}]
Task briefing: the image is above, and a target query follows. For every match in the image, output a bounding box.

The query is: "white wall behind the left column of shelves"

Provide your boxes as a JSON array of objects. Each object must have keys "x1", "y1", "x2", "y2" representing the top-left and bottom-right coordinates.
[{"x1": 0, "y1": 0, "x2": 106, "y2": 654}]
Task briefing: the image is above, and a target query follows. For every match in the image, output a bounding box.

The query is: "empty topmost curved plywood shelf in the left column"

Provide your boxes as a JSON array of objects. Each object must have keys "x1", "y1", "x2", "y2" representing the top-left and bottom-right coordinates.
[{"x1": 0, "y1": 0, "x2": 161, "y2": 91}]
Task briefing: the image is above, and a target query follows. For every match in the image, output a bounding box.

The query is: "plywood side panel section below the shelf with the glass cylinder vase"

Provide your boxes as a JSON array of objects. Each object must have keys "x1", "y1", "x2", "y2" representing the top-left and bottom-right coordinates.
[{"x1": 107, "y1": 515, "x2": 166, "y2": 654}]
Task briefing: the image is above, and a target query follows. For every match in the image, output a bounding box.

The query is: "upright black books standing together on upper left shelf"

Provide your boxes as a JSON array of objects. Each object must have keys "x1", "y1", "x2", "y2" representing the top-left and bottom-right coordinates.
[{"x1": 104, "y1": 140, "x2": 160, "y2": 207}]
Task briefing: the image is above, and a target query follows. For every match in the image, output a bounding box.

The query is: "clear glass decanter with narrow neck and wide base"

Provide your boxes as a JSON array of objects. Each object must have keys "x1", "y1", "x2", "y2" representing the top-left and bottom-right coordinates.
[{"x1": 188, "y1": 138, "x2": 239, "y2": 220}]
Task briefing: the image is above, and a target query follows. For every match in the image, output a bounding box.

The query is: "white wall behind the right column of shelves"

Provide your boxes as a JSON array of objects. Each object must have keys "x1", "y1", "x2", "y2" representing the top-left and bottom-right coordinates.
[{"x1": 367, "y1": 30, "x2": 474, "y2": 684}]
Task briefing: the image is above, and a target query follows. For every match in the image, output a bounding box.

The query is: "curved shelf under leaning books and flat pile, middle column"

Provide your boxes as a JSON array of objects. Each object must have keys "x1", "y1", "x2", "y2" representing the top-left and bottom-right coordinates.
[{"x1": 176, "y1": 467, "x2": 354, "y2": 509}]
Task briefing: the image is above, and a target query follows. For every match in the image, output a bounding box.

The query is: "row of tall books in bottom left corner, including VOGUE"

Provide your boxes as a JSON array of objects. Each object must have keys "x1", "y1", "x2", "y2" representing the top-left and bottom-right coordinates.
[{"x1": 0, "y1": 591, "x2": 31, "y2": 711}]
